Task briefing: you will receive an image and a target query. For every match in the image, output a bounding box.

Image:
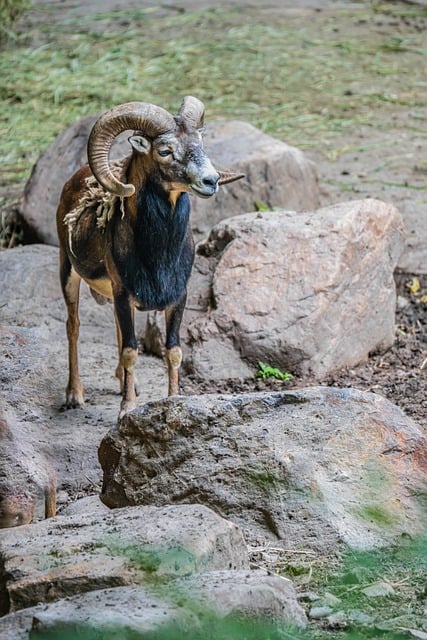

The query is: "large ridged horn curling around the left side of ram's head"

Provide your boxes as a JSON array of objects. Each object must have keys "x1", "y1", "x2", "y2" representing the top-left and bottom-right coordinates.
[{"x1": 87, "y1": 102, "x2": 175, "y2": 197}]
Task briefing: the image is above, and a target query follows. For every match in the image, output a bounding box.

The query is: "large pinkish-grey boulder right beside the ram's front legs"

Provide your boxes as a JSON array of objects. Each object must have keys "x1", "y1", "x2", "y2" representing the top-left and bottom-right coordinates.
[{"x1": 146, "y1": 199, "x2": 402, "y2": 379}]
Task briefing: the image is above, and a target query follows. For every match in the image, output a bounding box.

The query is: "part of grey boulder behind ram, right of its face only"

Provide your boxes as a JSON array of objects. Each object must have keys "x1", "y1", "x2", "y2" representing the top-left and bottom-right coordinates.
[{"x1": 192, "y1": 121, "x2": 319, "y2": 237}]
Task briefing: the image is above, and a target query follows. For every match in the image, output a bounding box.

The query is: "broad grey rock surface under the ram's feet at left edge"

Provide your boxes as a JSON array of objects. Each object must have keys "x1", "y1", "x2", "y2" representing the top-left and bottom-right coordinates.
[{"x1": 0, "y1": 245, "x2": 167, "y2": 526}]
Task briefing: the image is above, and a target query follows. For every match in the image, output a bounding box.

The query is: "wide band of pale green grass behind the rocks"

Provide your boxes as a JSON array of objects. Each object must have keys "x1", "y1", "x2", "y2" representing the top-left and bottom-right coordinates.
[{"x1": 0, "y1": 3, "x2": 427, "y2": 184}]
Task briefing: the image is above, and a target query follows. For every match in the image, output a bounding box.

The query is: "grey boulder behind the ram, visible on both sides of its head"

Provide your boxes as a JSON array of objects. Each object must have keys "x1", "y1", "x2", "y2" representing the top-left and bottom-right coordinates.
[{"x1": 20, "y1": 116, "x2": 319, "y2": 245}]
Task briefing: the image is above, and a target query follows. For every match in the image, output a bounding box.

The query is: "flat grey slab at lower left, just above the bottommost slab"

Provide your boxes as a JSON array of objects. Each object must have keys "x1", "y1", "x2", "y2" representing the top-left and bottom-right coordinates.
[{"x1": 0, "y1": 505, "x2": 249, "y2": 614}]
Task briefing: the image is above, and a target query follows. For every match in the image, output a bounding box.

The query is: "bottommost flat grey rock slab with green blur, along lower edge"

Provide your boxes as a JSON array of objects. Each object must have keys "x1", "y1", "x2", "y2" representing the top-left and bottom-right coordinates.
[{"x1": 0, "y1": 570, "x2": 306, "y2": 640}]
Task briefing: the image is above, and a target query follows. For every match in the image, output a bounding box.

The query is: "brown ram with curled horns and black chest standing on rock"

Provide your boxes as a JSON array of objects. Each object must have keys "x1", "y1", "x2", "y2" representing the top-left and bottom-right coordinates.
[{"x1": 57, "y1": 96, "x2": 243, "y2": 415}]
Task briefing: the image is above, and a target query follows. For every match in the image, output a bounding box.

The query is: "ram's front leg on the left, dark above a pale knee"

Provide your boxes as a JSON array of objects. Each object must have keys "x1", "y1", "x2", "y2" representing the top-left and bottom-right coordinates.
[{"x1": 114, "y1": 292, "x2": 138, "y2": 418}]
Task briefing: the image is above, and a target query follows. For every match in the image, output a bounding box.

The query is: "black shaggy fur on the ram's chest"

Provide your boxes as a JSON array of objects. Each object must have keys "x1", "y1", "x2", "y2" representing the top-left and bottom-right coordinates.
[{"x1": 113, "y1": 182, "x2": 194, "y2": 309}]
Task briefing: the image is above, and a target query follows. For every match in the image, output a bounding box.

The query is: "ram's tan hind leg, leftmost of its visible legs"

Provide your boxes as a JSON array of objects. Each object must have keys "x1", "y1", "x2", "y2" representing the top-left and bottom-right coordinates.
[{"x1": 60, "y1": 256, "x2": 84, "y2": 408}]
